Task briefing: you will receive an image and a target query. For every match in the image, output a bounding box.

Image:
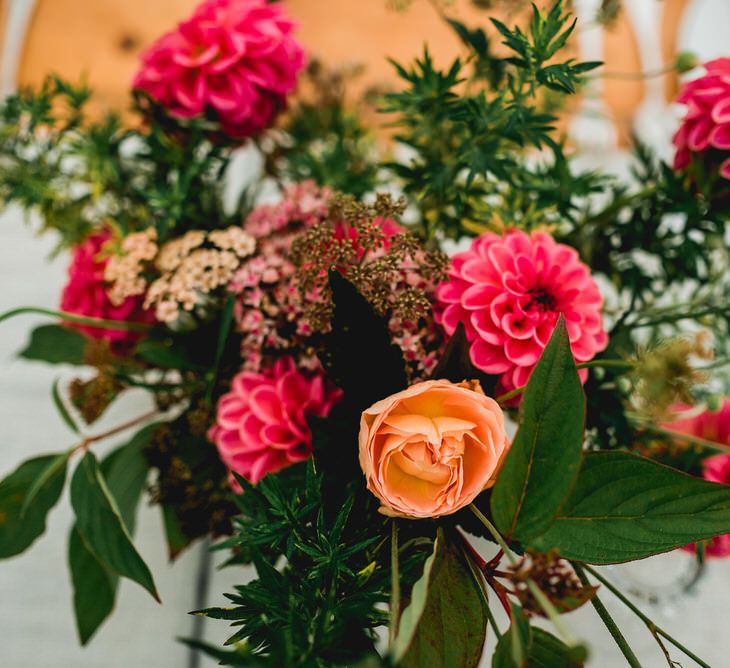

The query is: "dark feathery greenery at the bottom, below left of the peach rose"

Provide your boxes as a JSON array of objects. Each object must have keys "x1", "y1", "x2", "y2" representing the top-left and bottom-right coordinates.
[{"x1": 199, "y1": 461, "x2": 410, "y2": 667}]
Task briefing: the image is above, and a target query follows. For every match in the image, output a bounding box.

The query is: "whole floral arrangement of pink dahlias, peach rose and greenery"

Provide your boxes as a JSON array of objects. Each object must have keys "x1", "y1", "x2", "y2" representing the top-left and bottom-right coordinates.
[{"x1": 0, "y1": 0, "x2": 730, "y2": 667}]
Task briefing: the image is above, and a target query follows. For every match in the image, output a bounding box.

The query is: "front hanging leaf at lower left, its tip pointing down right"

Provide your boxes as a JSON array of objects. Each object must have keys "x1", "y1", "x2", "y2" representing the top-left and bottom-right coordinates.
[{"x1": 71, "y1": 452, "x2": 160, "y2": 601}]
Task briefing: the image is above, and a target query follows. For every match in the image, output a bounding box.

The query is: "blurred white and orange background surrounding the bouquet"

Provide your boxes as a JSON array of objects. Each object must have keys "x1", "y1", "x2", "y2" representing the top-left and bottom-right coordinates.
[{"x1": 0, "y1": 0, "x2": 730, "y2": 668}]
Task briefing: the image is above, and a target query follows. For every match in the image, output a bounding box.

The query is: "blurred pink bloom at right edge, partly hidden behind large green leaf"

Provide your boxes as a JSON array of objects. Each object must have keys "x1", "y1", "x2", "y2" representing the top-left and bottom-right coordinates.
[{"x1": 665, "y1": 398, "x2": 730, "y2": 557}]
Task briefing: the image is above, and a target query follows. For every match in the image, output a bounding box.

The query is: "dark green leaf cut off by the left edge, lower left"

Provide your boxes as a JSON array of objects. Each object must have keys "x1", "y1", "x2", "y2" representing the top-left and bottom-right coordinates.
[{"x1": 0, "y1": 455, "x2": 66, "y2": 559}]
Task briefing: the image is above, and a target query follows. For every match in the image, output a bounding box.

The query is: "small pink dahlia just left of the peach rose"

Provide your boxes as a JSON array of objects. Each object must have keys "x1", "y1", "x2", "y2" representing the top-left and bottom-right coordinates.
[{"x1": 209, "y1": 357, "x2": 342, "y2": 483}]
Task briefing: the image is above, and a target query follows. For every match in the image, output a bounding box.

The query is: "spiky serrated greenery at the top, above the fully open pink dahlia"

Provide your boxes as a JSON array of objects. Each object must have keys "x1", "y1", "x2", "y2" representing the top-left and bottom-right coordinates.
[{"x1": 383, "y1": 2, "x2": 602, "y2": 238}]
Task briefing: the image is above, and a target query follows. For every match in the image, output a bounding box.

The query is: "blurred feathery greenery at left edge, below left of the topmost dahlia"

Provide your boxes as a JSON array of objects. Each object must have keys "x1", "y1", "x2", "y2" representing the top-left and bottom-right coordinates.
[{"x1": 0, "y1": 76, "x2": 245, "y2": 252}]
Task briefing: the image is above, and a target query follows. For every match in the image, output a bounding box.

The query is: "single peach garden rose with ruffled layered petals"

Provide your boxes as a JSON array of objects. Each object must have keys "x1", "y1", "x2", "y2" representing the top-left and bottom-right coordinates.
[{"x1": 359, "y1": 380, "x2": 509, "y2": 519}]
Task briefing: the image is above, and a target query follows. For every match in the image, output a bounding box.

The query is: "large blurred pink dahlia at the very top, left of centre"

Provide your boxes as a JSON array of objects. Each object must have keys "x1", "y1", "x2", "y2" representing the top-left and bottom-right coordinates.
[{"x1": 133, "y1": 0, "x2": 305, "y2": 138}]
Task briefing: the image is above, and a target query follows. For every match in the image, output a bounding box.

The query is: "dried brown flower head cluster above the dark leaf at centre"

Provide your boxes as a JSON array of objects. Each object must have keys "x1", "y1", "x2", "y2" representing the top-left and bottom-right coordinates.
[{"x1": 291, "y1": 194, "x2": 448, "y2": 380}]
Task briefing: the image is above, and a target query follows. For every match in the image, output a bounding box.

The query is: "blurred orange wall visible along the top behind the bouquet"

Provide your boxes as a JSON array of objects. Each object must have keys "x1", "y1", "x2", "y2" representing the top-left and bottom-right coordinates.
[{"x1": 0, "y1": 0, "x2": 687, "y2": 140}]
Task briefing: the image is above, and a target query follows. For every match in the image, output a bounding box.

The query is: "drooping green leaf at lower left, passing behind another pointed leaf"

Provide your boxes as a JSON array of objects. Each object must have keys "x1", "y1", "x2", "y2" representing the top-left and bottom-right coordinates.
[{"x1": 68, "y1": 424, "x2": 158, "y2": 645}]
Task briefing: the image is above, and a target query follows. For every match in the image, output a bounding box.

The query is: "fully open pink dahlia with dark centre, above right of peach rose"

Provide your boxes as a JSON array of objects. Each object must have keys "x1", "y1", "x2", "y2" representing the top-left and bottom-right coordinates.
[{"x1": 436, "y1": 230, "x2": 608, "y2": 391}]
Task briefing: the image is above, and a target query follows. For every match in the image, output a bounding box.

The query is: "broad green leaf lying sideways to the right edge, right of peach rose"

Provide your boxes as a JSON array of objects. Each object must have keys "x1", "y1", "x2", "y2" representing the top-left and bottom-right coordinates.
[{"x1": 528, "y1": 451, "x2": 730, "y2": 564}]
